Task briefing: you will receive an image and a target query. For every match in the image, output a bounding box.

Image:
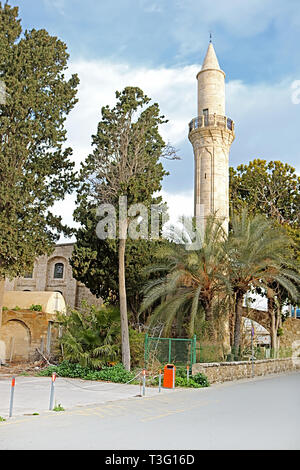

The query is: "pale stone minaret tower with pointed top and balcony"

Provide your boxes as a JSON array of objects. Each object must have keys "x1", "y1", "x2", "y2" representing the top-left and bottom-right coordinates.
[{"x1": 189, "y1": 42, "x2": 234, "y2": 231}]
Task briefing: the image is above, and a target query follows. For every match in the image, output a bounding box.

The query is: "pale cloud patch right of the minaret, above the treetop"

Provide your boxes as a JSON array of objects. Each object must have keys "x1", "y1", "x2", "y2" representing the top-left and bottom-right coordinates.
[{"x1": 227, "y1": 77, "x2": 300, "y2": 174}]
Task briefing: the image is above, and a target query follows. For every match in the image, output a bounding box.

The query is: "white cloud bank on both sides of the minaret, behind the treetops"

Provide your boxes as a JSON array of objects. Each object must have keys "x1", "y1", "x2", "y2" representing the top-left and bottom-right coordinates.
[{"x1": 55, "y1": 60, "x2": 300, "y2": 239}]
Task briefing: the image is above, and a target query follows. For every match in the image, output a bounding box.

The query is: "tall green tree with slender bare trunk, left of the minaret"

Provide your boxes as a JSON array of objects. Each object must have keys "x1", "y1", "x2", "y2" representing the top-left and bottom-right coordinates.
[{"x1": 75, "y1": 87, "x2": 174, "y2": 370}]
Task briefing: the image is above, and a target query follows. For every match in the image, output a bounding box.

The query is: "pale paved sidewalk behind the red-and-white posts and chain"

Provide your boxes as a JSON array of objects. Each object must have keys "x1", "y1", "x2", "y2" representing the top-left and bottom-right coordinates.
[{"x1": 0, "y1": 376, "x2": 174, "y2": 418}]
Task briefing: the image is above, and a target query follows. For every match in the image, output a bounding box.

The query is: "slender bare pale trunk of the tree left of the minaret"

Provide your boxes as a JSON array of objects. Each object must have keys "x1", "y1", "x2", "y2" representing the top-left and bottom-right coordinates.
[{"x1": 119, "y1": 234, "x2": 130, "y2": 370}]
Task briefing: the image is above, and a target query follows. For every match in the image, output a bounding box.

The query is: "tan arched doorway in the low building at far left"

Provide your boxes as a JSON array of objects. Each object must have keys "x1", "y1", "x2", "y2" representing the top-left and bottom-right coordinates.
[{"x1": 0, "y1": 320, "x2": 31, "y2": 362}]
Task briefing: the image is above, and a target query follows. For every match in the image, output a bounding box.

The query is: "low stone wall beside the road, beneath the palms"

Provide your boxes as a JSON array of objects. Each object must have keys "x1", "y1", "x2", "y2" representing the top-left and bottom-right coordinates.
[{"x1": 192, "y1": 358, "x2": 300, "y2": 383}]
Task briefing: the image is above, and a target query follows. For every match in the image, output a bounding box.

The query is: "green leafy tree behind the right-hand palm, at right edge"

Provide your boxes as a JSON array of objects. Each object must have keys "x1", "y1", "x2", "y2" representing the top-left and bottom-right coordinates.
[{"x1": 230, "y1": 159, "x2": 300, "y2": 349}]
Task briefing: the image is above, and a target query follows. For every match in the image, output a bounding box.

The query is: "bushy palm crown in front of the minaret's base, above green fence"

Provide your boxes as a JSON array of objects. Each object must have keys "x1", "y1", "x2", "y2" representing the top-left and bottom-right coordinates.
[{"x1": 141, "y1": 216, "x2": 230, "y2": 337}]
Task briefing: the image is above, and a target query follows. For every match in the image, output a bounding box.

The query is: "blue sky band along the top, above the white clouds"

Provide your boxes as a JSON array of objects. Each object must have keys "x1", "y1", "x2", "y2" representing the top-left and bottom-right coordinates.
[{"x1": 10, "y1": 0, "x2": 300, "y2": 83}]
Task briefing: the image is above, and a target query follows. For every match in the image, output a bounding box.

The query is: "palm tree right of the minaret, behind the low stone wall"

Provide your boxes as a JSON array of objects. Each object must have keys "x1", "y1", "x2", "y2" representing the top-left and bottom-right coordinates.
[{"x1": 225, "y1": 210, "x2": 300, "y2": 354}]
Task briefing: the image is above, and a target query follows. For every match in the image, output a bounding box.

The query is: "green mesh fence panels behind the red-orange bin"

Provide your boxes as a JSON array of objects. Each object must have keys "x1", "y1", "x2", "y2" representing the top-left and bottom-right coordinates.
[{"x1": 145, "y1": 335, "x2": 196, "y2": 369}]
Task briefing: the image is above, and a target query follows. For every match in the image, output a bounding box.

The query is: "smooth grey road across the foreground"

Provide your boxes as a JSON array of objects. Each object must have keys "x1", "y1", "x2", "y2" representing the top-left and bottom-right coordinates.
[{"x1": 0, "y1": 372, "x2": 300, "y2": 450}]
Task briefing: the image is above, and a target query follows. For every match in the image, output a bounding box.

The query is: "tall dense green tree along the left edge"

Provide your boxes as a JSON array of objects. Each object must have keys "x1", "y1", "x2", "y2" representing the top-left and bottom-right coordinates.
[{"x1": 0, "y1": 3, "x2": 79, "y2": 326}]
